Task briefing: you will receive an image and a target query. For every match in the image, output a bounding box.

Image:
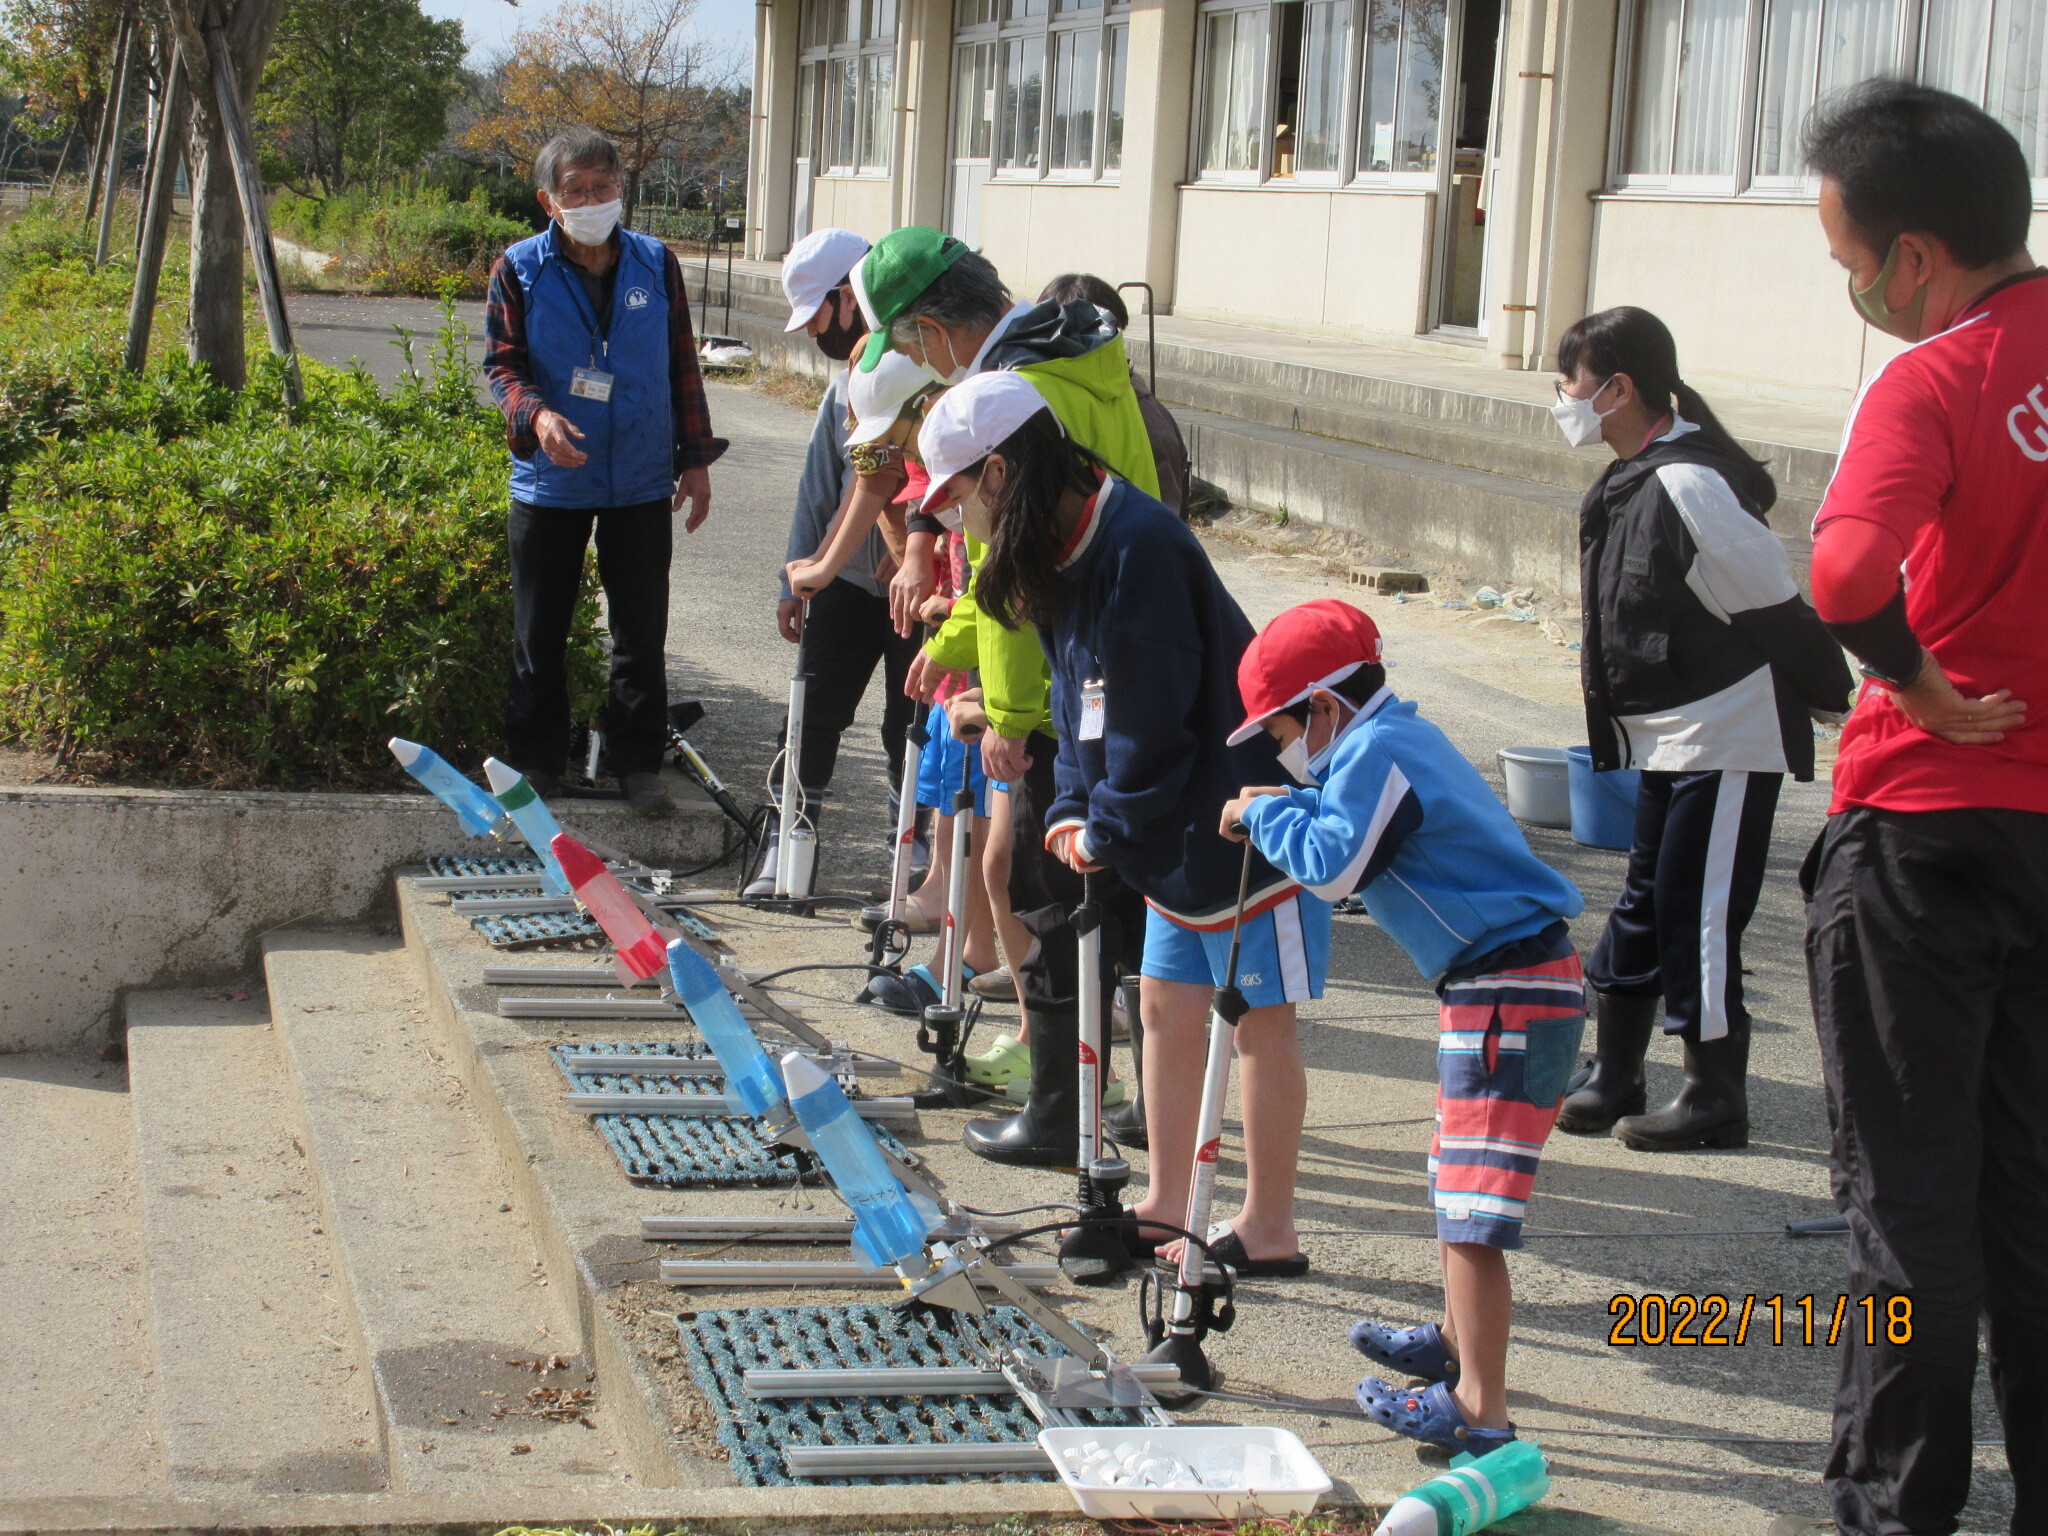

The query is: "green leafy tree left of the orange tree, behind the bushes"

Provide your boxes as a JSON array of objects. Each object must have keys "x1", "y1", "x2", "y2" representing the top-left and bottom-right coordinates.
[{"x1": 256, "y1": 0, "x2": 463, "y2": 193}]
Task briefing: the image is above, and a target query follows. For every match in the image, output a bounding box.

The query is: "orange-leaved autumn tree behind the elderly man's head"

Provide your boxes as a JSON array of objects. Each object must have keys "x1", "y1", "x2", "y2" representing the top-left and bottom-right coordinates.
[{"x1": 463, "y1": 0, "x2": 741, "y2": 221}]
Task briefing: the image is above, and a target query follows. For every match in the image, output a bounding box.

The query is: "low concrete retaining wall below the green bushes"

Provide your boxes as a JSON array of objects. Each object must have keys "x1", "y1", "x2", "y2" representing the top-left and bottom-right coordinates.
[{"x1": 0, "y1": 788, "x2": 723, "y2": 1053}]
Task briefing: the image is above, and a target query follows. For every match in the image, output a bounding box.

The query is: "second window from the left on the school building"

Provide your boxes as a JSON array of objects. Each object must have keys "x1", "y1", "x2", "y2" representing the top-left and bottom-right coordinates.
[{"x1": 946, "y1": 0, "x2": 1133, "y2": 186}]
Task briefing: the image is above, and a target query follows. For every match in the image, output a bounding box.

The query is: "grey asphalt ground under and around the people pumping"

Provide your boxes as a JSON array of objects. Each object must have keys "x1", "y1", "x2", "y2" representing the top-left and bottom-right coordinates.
[{"x1": 293, "y1": 295, "x2": 2011, "y2": 1536}]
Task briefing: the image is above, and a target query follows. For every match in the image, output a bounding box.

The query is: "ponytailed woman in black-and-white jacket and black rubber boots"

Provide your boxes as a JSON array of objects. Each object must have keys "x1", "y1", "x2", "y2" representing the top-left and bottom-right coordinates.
[{"x1": 1552, "y1": 307, "x2": 1849, "y2": 1151}]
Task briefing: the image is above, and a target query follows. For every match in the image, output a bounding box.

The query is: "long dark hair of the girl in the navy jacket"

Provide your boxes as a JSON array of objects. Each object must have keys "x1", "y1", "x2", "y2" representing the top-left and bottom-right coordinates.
[{"x1": 975, "y1": 410, "x2": 1102, "y2": 629}]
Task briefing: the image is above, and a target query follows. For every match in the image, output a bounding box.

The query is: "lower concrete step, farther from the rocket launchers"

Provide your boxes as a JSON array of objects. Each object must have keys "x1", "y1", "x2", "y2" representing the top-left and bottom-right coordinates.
[{"x1": 127, "y1": 991, "x2": 387, "y2": 1493}]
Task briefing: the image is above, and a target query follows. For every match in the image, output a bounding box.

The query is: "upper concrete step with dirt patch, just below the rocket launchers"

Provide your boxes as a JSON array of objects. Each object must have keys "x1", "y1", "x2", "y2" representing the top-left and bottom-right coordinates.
[{"x1": 264, "y1": 934, "x2": 629, "y2": 1493}]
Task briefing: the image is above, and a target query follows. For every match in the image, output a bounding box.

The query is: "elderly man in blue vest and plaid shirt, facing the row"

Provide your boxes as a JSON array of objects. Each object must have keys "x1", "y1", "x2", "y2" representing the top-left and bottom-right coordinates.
[{"x1": 483, "y1": 129, "x2": 725, "y2": 815}]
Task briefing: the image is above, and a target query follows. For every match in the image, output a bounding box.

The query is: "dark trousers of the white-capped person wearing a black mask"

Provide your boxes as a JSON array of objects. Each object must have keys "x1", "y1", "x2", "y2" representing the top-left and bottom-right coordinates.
[{"x1": 776, "y1": 582, "x2": 920, "y2": 803}]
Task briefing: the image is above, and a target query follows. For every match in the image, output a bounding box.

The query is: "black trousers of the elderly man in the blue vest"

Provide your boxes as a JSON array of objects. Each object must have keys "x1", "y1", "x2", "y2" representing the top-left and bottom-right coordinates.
[{"x1": 506, "y1": 500, "x2": 672, "y2": 774}]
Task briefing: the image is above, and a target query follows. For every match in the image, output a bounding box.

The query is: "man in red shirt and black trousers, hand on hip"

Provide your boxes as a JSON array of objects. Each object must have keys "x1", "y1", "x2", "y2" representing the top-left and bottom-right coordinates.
[{"x1": 1800, "y1": 80, "x2": 2048, "y2": 1536}]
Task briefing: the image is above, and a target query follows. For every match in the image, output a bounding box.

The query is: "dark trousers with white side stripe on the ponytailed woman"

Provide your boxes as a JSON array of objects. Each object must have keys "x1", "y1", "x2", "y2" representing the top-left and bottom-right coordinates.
[{"x1": 1585, "y1": 770, "x2": 1784, "y2": 1042}]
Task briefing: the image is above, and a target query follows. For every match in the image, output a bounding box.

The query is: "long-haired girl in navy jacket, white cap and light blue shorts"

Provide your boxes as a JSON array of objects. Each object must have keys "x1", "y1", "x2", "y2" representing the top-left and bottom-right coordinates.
[{"x1": 918, "y1": 373, "x2": 1331, "y2": 1278}]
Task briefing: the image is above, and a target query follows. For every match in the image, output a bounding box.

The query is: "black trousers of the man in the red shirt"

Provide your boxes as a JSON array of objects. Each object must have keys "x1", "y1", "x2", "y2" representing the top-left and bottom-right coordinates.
[{"x1": 1800, "y1": 809, "x2": 2048, "y2": 1536}]
